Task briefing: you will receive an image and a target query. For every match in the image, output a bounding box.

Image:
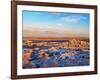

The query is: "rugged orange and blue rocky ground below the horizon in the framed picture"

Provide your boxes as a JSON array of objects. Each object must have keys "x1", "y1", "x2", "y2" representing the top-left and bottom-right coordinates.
[{"x1": 23, "y1": 39, "x2": 90, "y2": 69}]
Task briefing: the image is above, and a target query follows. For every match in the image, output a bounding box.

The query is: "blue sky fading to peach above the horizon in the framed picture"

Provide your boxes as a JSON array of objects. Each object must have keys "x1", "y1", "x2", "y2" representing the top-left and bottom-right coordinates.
[{"x1": 22, "y1": 11, "x2": 90, "y2": 37}]
